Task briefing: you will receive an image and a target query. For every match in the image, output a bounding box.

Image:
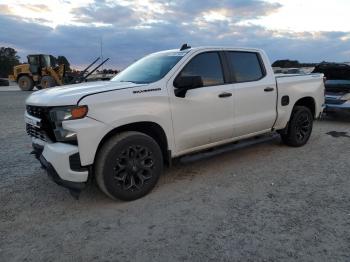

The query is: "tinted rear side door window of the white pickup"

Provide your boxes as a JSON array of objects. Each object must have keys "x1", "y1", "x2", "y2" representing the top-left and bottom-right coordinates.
[{"x1": 226, "y1": 51, "x2": 266, "y2": 83}]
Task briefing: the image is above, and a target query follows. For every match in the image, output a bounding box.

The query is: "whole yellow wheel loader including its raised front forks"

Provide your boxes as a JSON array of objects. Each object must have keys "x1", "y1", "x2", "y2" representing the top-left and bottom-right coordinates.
[{"x1": 9, "y1": 54, "x2": 109, "y2": 91}]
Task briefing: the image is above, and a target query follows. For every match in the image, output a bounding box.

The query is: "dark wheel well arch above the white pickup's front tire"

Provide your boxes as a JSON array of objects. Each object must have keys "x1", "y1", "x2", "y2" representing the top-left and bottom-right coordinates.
[{"x1": 97, "y1": 122, "x2": 171, "y2": 165}]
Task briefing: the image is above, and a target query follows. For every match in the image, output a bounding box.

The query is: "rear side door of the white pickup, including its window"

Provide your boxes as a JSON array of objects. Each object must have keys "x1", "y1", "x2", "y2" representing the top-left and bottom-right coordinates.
[{"x1": 226, "y1": 51, "x2": 277, "y2": 137}]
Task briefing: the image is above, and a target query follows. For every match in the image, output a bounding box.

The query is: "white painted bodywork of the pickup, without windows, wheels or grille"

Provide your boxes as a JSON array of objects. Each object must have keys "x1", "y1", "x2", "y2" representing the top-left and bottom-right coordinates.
[{"x1": 26, "y1": 47, "x2": 324, "y2": 182}]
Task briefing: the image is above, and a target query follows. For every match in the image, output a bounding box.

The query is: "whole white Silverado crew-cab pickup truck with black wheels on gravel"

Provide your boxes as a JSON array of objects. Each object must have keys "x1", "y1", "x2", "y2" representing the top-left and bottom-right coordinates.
[{"x1": 25, "y1": 45, "x2": 324, "y2": 200}]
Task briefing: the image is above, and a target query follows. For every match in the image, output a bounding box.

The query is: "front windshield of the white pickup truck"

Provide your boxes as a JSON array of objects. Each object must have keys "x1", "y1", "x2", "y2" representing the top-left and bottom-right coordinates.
[{"x1": 111, "y1": 52, "x2": 187, "y2": 84}]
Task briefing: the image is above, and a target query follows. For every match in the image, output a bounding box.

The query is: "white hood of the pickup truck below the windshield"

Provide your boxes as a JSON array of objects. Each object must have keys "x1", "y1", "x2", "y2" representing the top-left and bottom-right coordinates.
[{"x1": 26, "y1": 81, "x2": 143, "y2": 106}]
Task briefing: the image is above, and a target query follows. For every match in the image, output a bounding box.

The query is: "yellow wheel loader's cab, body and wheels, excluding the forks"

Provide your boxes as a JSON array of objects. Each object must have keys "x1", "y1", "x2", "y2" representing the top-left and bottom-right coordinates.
[{"x1": 9, "y1": 54, "x2": 66, "y2": 91}]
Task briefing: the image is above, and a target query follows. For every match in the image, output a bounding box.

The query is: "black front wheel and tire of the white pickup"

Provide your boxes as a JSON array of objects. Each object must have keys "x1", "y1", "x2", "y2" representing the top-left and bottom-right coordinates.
[{"x1": 94, "y1": 131, "x2": 163, "y2": 201}]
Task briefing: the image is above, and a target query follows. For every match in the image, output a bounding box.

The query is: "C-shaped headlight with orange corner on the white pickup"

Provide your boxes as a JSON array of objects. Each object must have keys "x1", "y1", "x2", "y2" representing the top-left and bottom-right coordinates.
[{"x1": 50, "y1": 106, "x2": 88, "y2": 142}]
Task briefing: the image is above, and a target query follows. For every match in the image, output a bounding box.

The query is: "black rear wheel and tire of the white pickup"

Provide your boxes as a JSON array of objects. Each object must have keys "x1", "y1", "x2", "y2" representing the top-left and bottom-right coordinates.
[{"x1": 280, "y1": 106, "x2": 313, "y2": 147}]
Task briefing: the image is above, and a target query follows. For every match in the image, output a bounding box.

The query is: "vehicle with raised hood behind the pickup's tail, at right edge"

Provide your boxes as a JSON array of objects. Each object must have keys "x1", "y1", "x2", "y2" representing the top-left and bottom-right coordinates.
[{"x1": 313, "y1": 62, "x2": 350, "y2": 112}]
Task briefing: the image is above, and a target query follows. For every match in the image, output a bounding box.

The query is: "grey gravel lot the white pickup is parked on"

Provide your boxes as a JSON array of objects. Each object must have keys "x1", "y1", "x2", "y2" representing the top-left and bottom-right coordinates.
[{"x1": 0, "y1": 91, "x2": 350, "y2": 262}]
